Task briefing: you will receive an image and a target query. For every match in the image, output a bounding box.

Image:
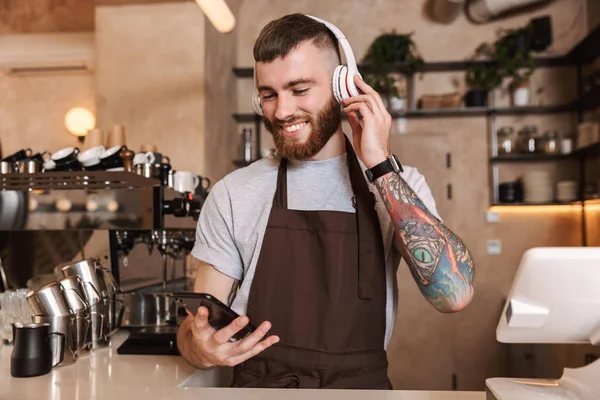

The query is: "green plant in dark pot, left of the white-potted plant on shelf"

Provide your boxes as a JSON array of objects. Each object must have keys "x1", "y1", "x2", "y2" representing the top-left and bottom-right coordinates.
[{"x1": 465, "y1": 43, "x2": 503, "y2": 107}]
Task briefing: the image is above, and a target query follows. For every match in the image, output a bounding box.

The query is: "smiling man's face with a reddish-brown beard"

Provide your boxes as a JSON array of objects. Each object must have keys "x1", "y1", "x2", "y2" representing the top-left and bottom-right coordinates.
[{"x1": 256, "y1": 41, "x2": 341, "y2": 160}]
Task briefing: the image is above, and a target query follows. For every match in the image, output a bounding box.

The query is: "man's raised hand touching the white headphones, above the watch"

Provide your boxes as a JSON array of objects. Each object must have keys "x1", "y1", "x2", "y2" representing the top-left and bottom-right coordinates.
[{"x1": 343, "y1": 75, "x2": 392, "y2": 168}]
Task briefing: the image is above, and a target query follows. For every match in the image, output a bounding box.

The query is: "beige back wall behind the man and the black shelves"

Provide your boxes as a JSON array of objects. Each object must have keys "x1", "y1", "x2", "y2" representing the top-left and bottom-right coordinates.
[{"x1": 230, "y1": 0, "x2": 587, "y2": 390}]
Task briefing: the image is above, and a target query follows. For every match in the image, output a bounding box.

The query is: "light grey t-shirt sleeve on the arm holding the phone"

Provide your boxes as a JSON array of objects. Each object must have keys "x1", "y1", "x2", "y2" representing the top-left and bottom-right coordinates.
[{"x1": 192, "y1": 180, "x2": 244, "y2": 280}]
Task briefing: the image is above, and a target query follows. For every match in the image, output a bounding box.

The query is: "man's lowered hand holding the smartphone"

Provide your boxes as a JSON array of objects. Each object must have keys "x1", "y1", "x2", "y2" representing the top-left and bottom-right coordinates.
[{"x1": 188, "y1": 307, "x2": 279, "y2": 368}]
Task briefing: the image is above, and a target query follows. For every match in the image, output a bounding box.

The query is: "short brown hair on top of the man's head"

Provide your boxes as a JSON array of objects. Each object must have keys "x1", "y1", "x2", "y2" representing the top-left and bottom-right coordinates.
[{"x1": 253, "y1": 13, "x2": 341, "y2": 62}]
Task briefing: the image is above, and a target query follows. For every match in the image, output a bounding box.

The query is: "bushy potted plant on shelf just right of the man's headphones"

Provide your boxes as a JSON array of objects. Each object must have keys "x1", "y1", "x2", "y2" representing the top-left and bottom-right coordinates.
[{"x1": 362, "y1": 31, "x2": 424, "y2": 111}]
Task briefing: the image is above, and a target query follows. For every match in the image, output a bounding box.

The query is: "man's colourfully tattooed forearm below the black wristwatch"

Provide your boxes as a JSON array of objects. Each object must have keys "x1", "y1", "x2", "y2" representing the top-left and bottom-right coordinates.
[{"x1": 375, "y1": 173, "x2": 475, "y2": 313}]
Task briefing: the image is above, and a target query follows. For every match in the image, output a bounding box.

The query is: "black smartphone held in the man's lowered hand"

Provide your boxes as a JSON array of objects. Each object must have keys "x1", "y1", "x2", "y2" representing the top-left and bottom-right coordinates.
[{"x1": 172, "y1": 292, "x2": 256, "y2": 340}]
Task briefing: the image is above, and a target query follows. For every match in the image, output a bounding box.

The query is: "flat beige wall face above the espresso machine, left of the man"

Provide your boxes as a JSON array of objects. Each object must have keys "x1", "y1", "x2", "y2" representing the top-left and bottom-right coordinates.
[{"x1": 96, "y1": 2, "x2": 205, "y2": 174}]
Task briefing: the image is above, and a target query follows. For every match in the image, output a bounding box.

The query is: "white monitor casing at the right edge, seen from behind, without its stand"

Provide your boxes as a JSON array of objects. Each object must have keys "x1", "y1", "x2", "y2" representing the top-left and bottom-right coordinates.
[{"x1": 496, "y1": 247, "x2": 600, "y2": 345}]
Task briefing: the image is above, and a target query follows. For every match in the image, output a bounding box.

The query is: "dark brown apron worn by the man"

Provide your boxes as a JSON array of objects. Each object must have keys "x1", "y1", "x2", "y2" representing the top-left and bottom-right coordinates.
[{"x1": 232, "y1": 136, "x2": 392, "y2": 389}]
